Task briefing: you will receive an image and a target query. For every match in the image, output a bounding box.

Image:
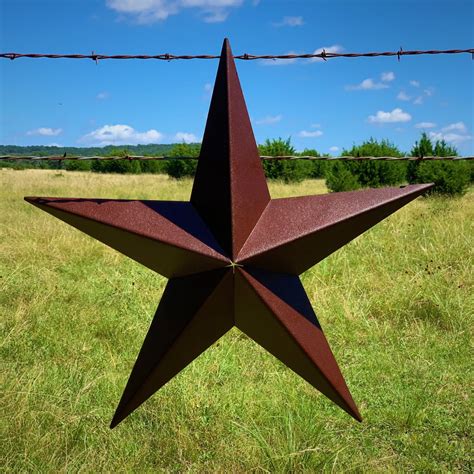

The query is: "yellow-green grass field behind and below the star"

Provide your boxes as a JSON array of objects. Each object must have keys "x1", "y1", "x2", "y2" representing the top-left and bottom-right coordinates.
[{"x1": 0, "y1": 170, "x2": 474, "y2": 473}]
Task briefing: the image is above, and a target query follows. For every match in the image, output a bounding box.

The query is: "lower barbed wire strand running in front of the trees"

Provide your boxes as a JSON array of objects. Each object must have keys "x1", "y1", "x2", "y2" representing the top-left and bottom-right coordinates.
[{"x1": 0, "y1": 154, "x2": 474, "y2": 161}]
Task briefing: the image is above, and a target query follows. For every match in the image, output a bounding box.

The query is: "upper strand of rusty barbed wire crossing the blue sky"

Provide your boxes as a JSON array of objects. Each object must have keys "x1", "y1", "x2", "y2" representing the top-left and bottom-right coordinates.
[{"x1": 0, "y1": 47, "x2": 474, "y2": 63}]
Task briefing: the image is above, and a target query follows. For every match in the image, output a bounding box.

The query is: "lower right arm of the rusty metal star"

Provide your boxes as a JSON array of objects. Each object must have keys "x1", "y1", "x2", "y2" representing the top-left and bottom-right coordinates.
[{"x1": 234, "y1": 266, "x2": 362, "y2": 421}]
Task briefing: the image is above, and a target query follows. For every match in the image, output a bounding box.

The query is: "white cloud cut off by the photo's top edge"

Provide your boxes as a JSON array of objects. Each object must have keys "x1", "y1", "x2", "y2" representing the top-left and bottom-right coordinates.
[{"x1": 106, "y1": 0, "x2": 243, "y2": 24}]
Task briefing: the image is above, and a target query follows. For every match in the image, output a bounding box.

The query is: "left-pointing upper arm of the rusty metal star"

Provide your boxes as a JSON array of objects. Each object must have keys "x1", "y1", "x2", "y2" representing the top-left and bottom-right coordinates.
[{"x1": 25, "y1": 198, "x2": 229, "y2": 278}]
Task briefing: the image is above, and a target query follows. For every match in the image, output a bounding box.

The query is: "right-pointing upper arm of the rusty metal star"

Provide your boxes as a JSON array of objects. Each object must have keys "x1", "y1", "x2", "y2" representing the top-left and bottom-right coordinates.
[{"x1": 237, "y1": 184, "x2": 432, "y2": 275}]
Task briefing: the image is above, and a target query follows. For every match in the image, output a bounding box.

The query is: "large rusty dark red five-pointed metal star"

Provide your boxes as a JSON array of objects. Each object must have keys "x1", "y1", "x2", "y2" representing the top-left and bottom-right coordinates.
[{"x1": 25, "y1": 40, "x2": 430, "y2": 427}]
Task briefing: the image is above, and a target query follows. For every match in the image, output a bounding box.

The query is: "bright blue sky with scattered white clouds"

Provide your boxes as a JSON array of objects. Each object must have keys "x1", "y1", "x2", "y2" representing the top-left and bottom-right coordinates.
[{"x1": 0, "y1": 0, "x2": 474, "y2": 155}]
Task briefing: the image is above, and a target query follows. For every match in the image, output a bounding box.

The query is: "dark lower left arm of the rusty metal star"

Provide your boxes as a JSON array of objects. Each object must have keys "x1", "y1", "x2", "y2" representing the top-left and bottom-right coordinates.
[{"x1": 111, "y1": 268, "x2": 234, "y2": 428}]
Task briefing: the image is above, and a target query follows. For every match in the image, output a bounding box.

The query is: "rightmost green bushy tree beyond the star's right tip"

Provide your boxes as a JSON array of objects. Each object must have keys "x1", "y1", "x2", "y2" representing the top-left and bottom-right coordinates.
[{"x1": 407, "y1": 132, "x2": 472, "y2": 196}]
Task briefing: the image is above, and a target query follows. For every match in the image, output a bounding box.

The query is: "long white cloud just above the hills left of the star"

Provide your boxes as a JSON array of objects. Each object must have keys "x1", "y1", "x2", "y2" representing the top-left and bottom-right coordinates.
[{"x1": 79, "y1": 124, "x2": 163, "y2": 146}]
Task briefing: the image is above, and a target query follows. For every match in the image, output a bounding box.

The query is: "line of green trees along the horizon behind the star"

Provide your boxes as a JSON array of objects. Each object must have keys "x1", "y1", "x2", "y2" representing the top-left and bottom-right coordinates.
[{"x1": 0, "y1": 133, "x2": 474, "y2": 195}]
